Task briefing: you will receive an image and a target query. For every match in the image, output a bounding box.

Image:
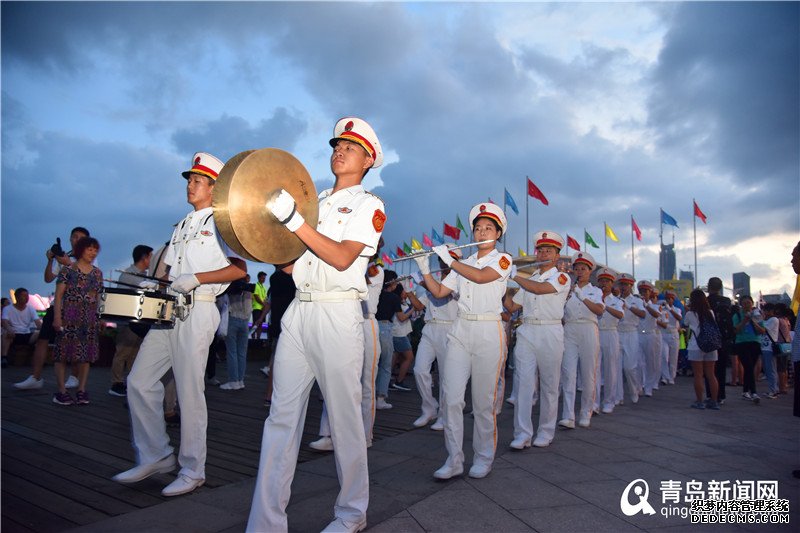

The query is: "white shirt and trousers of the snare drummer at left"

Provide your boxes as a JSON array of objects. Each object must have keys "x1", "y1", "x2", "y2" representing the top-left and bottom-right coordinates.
[{"x1": 128, "y1": 207, "x2": 231, "y2": 479}]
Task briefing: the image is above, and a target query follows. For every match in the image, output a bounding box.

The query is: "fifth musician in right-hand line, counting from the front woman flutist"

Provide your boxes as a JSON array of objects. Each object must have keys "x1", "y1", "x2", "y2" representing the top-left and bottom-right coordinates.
[{"x1": 617, "y1": 273, "x2": 645, "y2": 403}]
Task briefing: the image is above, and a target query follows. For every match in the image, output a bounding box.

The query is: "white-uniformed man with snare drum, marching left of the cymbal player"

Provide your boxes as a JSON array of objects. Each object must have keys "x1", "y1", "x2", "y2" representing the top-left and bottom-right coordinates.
[{"x1": 113, "y1": 152, "x2": 247, "y2": 496}]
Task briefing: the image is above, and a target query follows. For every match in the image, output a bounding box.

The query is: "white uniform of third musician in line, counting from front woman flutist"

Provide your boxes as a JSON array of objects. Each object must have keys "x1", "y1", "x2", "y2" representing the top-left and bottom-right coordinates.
[{"x1": 561, "y1": 284, "x2": 603, "y2": 422}]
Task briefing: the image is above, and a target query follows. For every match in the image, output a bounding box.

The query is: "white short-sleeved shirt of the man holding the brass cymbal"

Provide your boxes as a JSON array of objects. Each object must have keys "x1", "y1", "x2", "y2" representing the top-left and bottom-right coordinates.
[{"x1": 292, "y1": 185, "x2": 386, "y2": 300}]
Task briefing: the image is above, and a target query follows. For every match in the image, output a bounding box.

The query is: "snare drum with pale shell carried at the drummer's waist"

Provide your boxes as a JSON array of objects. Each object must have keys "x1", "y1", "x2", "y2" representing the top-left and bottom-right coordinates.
[{"x1": 97, "y1": 287, "x2": 175, "y2": 325}]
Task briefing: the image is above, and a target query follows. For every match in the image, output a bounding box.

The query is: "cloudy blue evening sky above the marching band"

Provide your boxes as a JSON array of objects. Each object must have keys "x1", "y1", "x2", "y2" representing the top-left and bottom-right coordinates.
[{"x1": 0, "y1": 2, "x2": 800, "y2": 295}]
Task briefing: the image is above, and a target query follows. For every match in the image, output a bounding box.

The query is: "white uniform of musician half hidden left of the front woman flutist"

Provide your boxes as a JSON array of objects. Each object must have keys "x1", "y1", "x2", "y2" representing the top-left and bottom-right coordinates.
[{"x1": 414, "y1": 293, "x2": 458, "y2": 423}]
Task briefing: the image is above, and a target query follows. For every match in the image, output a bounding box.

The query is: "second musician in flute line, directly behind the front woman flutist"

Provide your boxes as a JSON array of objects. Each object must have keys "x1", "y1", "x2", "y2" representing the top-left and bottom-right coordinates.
[{"x1": 505, "y1": 231, "x2": 571, "y2": 450}]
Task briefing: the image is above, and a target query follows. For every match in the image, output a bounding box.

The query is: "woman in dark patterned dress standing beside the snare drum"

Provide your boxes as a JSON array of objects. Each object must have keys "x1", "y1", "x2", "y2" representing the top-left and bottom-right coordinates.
[{"x1": 53, "y1": 237, "x2": 103, "y2": 405}]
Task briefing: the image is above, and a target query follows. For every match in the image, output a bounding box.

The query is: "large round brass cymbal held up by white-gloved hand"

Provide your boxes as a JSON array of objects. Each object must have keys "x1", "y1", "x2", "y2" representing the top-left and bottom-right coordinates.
[{"x1": 212, "y1": 148, "x2": 319, "y2": 264}]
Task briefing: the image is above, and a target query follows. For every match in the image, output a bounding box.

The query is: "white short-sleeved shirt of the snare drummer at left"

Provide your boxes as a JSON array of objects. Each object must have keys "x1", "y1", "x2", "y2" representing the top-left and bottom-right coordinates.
[{"x1": 164, "y1": 207, "x2": 238, "y2": 296}]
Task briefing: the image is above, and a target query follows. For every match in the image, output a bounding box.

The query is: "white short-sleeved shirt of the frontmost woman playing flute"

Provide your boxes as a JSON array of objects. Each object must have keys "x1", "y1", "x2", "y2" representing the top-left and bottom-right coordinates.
[{"x1": 442, "y1": 249, "x2": 511, "y2": 317}]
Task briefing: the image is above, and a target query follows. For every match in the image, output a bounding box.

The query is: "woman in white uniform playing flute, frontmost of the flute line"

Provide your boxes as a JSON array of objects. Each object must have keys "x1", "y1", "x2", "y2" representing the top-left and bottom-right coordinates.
[{"x1": 416, "y1": 203, "x2": 512, "y2": 479}]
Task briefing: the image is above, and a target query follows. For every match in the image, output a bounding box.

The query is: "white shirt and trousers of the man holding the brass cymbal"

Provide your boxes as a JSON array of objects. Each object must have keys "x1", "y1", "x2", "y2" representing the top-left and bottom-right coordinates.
[{"x1": 247, "y1": 185, "x2": 385, "y2": 532}]
